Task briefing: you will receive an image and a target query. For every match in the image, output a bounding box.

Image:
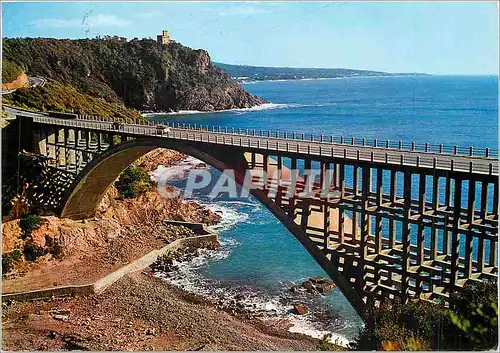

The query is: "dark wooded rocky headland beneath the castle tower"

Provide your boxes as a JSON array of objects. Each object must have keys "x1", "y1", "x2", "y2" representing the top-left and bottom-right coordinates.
[{"x1": 3, "y1": 38, "x2": 265, "y2": 111}]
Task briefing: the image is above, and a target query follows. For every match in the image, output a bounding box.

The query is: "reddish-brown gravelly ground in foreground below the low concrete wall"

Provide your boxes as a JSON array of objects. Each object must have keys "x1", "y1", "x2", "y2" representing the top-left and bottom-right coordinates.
[{"x1": 2, "y1": 272, "x2": 318, "y2": 351}]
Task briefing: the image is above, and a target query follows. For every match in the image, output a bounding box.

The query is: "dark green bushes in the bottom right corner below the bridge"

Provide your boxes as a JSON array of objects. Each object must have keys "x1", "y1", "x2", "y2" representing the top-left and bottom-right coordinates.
[{"x1": 351, "y1": 281, "x2": 498, "y2": 351}]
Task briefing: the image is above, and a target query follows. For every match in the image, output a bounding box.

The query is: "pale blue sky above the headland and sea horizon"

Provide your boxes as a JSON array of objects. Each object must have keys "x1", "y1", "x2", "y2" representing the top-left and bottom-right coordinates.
[{"x1": 2, "y1": 1, "x2": 499, "y2": 75}]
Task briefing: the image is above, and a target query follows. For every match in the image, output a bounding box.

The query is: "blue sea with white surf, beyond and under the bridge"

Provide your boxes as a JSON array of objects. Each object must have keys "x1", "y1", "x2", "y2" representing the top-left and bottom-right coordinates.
[{"x1": 145, "y1": 76, "x2": 498, "y2": 345}]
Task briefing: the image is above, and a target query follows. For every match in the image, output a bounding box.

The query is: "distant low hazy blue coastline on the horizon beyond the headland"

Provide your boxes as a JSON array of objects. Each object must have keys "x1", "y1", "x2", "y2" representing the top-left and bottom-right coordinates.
[{"x1": 214, "y1": 63, "x2": 421, "y2": 81}]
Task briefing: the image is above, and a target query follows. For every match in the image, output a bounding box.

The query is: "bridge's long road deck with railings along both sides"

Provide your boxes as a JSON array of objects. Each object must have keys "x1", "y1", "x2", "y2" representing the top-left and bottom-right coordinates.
[{"x1": 33, "y1": 117, "x2": 498, "y2": 175}]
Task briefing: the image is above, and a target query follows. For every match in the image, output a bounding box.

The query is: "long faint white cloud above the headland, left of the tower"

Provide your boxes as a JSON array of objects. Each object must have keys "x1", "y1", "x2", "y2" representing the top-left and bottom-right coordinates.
[{"x1": 31, "y1": 14, "x2": 131, "y2": 28}]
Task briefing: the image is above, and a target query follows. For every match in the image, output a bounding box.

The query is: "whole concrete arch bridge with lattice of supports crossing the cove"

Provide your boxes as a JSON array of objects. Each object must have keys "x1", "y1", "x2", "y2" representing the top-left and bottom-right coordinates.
[{"x1": 9, "y1": 111, "x2": 499, "y2": 316}]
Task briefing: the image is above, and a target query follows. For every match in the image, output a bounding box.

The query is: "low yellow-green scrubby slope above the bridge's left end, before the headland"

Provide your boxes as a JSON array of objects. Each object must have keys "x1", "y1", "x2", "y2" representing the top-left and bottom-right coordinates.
[{"x1": 2, "y1": 81, "x2": 144, "y2": 122}]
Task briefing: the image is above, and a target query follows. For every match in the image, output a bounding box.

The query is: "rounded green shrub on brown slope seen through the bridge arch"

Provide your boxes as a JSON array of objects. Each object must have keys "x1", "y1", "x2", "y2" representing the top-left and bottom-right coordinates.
[{"x1": 115, "y1": 166, "x2": 154, "y2": 199}]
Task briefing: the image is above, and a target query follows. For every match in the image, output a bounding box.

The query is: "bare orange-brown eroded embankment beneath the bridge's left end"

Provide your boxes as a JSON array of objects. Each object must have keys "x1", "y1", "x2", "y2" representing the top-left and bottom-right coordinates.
[{"x1": 2, "y1": 150, "x2": 219, "y2": 293}]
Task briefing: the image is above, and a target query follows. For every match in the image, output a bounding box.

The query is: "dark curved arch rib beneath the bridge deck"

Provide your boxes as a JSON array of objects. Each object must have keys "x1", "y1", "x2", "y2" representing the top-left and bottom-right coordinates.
[{"x1": 61, "y1": 137, "x2": 366, "y2": 318}]
